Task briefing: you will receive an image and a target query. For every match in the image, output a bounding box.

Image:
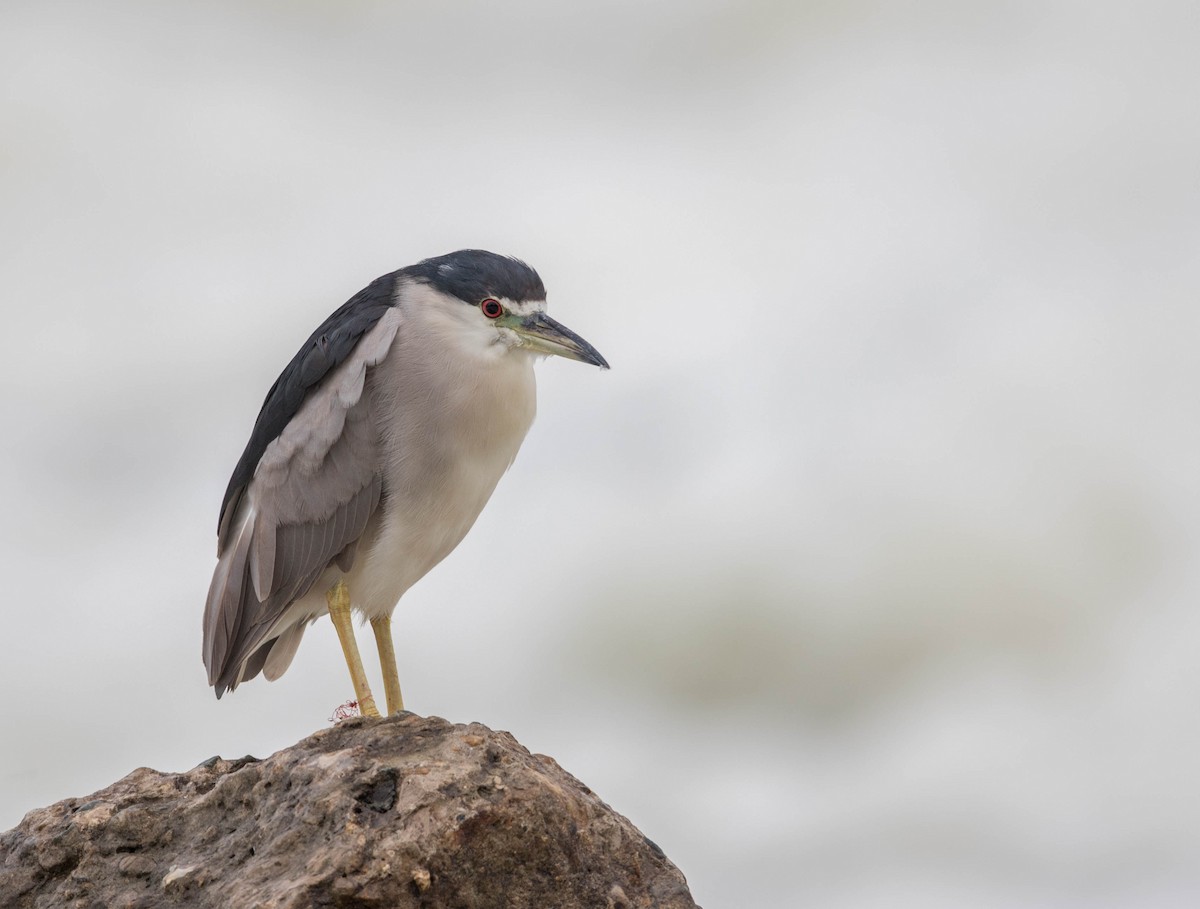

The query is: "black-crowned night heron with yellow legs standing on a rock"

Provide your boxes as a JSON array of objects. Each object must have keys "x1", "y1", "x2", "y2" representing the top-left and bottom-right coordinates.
[{"x1": 203, "y1": 249, "x2": 608, "y2": 716}]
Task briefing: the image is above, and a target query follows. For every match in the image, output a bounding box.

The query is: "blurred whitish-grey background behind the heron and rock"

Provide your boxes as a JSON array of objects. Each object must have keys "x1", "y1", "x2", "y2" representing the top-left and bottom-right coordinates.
[{"x1": 0, "y1": 0, "x2": 1200, "y2": 909}]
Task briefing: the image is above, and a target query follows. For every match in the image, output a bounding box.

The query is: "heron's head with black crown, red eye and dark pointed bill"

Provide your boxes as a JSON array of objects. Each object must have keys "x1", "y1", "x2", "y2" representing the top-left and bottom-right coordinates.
[{"x1": 408, "y1": 249, "x2": 608, "y2": 369}]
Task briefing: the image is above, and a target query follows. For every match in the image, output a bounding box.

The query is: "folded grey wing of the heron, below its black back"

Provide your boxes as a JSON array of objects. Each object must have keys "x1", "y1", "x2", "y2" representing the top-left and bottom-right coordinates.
[{"x1": 204, "y1": 308, "x2": 400, "y2": 697}]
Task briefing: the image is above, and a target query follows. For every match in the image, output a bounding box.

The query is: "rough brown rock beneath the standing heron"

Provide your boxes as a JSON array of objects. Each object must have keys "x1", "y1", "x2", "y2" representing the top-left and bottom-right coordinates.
[{"x1": 0, "y1": 714, "x2": 695, "y2": 909}]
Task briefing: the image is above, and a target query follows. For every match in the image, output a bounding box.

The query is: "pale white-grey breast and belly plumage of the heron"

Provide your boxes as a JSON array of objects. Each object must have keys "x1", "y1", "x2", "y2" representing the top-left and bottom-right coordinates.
[{"x1": 348, "y1": 287, "x2": 536, "y2": 616}]
